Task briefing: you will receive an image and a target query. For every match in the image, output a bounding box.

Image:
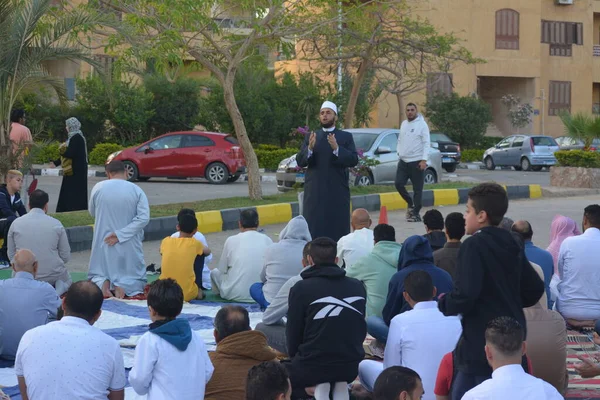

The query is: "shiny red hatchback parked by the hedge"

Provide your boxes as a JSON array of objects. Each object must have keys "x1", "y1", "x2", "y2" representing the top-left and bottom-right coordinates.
[{"x1": 106, "y1": 131, "x2": 246, "y2": 184}]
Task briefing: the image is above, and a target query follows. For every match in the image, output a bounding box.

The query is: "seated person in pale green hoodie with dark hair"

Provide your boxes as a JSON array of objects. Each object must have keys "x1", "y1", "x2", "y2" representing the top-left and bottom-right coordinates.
[{"x1": 346, "y1": 224, "x2": 402, "y2": 317}]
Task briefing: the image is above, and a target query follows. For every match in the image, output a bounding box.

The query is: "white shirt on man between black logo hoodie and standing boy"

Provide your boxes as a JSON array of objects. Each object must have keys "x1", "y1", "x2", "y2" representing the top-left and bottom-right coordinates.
[{"x1": 383, "y1": 301, "x2": 462, "y2": 400}]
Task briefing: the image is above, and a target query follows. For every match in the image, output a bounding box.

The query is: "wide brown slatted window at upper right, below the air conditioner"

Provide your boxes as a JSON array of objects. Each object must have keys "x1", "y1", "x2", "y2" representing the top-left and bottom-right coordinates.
[{"x1": 542, "y1": 21, "x2": 583, "y2": 57}]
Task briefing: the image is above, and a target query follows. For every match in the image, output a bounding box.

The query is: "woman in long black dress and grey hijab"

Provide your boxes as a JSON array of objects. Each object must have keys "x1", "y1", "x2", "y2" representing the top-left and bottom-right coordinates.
[{"x1": 51, "y1": 118, "x2": 88, "y2": 212}]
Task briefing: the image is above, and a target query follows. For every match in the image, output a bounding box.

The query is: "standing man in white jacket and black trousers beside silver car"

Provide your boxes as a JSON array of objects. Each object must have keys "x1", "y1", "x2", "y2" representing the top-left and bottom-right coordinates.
[{"x1": 395, "y1": 103, "x2": 430, "y2": 222}]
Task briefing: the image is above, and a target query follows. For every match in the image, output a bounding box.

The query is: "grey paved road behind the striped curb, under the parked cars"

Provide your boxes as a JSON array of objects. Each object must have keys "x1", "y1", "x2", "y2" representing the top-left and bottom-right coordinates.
[{"x1": 38, "y1": 170, "x2": 550, "y2": 212}]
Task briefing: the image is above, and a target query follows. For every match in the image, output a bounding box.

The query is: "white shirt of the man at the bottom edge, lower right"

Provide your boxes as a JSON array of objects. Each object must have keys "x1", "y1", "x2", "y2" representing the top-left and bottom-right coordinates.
[{"x1": 462, "y1": 364, "x2": 564, "y2": 400}]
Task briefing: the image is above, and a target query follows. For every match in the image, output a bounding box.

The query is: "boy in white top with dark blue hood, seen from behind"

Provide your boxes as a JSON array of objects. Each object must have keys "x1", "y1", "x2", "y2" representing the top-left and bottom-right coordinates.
[{"x1": 129, "y1": 279, "x2": 214, "y2": 400}]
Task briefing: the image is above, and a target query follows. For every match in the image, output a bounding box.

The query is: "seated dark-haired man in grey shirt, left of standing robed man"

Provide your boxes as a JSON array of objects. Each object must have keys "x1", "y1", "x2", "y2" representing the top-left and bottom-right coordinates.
[{"x1": 8, "y1": 189, "x2": 71, "y2": 296}]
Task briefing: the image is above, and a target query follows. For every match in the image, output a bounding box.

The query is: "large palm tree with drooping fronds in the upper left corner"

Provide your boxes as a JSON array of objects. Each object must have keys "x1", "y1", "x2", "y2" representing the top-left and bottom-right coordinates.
[{"x1": 0, "y1": 0, "x2": 110, "y2": 179}]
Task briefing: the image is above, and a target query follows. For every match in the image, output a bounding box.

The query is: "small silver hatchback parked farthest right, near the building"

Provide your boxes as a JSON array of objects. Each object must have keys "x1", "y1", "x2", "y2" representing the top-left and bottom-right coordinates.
[{"x1": 483, "y1": 135, "x2": 559, "y2": 171}]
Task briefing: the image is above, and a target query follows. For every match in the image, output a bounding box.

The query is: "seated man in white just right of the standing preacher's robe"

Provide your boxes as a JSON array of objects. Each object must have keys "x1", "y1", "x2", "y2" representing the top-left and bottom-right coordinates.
[{"x1": 337, "y1": 208, "x2": 374, "y2": 268}]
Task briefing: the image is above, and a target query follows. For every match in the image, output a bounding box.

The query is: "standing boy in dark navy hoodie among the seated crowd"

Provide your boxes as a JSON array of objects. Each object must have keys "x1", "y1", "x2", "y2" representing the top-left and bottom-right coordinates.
[{"x1": 438, "y1": 183, "x2": 544, "y2": 399}]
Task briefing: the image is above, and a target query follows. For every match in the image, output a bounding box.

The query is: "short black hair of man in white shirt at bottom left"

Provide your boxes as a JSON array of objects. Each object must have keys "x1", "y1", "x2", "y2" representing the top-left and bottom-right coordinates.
[{"x1": 65, "y1": 281, "x2": 104, "y2": 322}]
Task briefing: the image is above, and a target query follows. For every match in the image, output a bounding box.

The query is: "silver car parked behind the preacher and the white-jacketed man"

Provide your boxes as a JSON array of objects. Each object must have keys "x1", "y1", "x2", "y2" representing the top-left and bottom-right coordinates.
[{"x1": 276, "y1": 128, "x2": 442, "y2": 192}]
